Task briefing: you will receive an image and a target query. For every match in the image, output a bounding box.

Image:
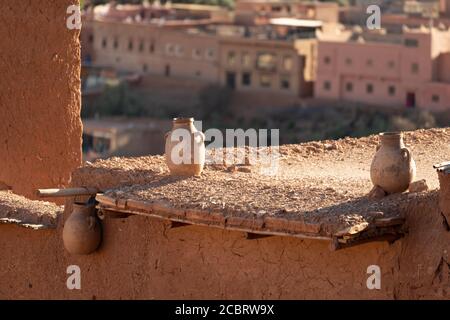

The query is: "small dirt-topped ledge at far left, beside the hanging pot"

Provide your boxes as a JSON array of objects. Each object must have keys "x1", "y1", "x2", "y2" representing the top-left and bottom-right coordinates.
[{"x1": 0, "y1": 191, "x2": 60, "y2": 229}]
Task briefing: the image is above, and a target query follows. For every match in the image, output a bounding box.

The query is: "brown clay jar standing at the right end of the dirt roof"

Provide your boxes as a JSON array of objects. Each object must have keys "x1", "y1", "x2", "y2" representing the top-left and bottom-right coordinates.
[{"x1": 370, "y1": 132, "x2": 416, "y2": 193}]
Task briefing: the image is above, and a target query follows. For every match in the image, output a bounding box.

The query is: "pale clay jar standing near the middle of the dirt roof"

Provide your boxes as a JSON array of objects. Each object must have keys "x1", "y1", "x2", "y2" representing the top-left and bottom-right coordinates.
[{"x1": 165, "y1": 118, "x2": 205, "y2": 176}]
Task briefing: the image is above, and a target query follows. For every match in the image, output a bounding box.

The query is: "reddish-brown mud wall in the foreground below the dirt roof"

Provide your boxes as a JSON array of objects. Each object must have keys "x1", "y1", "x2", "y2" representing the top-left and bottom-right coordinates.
[{"x1": 0, "y1": 190, "x2": 450, "y2": 299}]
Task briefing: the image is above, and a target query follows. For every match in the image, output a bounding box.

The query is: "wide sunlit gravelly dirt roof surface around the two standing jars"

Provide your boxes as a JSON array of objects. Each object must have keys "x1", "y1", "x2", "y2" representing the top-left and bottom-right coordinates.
[{"x1": 86, "y1": 129, "x2": 450, "y2": 236}]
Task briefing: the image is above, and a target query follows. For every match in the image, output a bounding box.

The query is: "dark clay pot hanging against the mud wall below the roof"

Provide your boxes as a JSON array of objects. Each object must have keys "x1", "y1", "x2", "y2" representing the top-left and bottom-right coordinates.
[{"x1": 63, "y1": 203, "x2": 102, "y2": 254}]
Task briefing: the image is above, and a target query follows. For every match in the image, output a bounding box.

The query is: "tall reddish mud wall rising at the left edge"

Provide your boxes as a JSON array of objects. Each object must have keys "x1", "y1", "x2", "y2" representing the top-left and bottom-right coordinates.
[{"x1": 0, "y1": 0, "x2": 82, "y2": 197}]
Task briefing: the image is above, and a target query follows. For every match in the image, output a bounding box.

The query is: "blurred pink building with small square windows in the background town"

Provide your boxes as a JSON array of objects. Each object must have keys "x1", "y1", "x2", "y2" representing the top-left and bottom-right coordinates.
[{"x1": 315, "y1": 28, "x2": 450, "y2": 110}]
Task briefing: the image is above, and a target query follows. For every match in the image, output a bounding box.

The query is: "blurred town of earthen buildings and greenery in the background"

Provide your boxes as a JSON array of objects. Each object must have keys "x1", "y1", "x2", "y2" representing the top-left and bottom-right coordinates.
[{"x1": 81, "y1": 0, "x2": 450, "y2": 160}]
